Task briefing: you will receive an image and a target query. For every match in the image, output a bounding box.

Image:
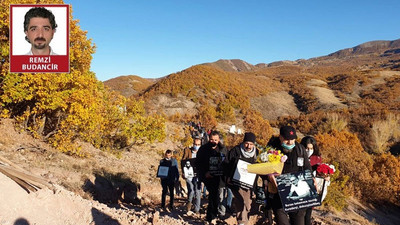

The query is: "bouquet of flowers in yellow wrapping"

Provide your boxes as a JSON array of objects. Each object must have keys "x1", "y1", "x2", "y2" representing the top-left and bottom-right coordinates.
[{"x1": 247, "y1": 145, "x2": 287, "y2": 175}]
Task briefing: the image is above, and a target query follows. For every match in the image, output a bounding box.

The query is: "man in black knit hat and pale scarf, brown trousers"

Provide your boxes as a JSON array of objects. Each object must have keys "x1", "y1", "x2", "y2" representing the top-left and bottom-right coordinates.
[{"x1": 226, "y1": 132, "x2": 258, "y2": 225}]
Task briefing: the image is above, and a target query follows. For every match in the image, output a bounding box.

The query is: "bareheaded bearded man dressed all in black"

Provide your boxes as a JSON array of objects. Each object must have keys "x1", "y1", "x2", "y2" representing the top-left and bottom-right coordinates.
[{"x1": 196, "y1": 131, "x2": 227, "y2": 223}]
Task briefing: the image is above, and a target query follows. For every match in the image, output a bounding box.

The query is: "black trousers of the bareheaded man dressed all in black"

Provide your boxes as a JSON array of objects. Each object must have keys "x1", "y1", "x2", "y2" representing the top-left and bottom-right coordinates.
[{"x1": 204, "y1": 177, "x2": 219, "y2": 221}]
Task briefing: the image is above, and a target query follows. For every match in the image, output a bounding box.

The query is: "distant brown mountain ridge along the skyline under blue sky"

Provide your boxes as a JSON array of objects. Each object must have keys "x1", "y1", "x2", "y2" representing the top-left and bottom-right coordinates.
[{"x1": 104, "y1": 39, "x2": 400, "y2": 97}]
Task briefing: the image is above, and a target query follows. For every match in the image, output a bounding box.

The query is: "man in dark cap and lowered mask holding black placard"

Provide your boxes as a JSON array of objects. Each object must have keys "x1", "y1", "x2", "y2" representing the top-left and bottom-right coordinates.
[{"x1": 267, "y1": 126, "x2": 311, "y2": 225}]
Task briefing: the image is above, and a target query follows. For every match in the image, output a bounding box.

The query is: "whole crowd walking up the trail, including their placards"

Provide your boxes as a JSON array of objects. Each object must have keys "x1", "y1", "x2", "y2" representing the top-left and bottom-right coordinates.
[{"x1": 157, "y1": 123, "x2": 334, "y2": 225}]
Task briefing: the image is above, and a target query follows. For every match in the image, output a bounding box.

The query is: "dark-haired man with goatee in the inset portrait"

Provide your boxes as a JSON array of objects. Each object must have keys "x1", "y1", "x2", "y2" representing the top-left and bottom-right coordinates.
[{"x1": 24, "y1": 7, "x2": 57, "y2": 55}]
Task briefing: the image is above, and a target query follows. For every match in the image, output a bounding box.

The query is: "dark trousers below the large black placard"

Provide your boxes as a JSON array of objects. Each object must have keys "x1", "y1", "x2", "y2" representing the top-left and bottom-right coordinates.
[{"x1": 270, "y1": 194, "x2": 306, "y2": 225}]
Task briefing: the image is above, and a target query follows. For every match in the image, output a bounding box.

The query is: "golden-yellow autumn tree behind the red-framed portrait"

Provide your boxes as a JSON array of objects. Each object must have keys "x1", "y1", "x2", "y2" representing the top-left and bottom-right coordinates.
[{"x1": 0, "y1": 0, "x2": 164, "y2": 155}]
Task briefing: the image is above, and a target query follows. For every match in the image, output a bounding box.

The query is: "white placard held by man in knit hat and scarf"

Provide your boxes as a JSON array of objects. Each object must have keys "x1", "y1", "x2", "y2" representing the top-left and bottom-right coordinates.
[{"x1": 232, "y1": 159, "x2": 257, "y2": 189}]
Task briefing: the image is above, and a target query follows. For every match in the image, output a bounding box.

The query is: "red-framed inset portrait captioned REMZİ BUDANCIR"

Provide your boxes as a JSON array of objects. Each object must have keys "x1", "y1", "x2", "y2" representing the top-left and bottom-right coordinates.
[{"x1": 10, "y1": 5, "x2": 69, "y2": 73}]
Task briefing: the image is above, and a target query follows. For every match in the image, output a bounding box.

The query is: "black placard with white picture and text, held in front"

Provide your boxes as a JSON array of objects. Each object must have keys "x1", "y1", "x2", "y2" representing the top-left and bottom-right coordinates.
[{"x1": 276, "y1": 170, "x2": 321, "y2": 212}]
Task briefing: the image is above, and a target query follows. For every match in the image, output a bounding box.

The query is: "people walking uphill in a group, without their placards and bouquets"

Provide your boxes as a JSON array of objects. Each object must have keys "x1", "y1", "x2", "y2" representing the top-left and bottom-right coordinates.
[{"x1": 160, "y1": 126, "x2": 330, "y2": 225}]
